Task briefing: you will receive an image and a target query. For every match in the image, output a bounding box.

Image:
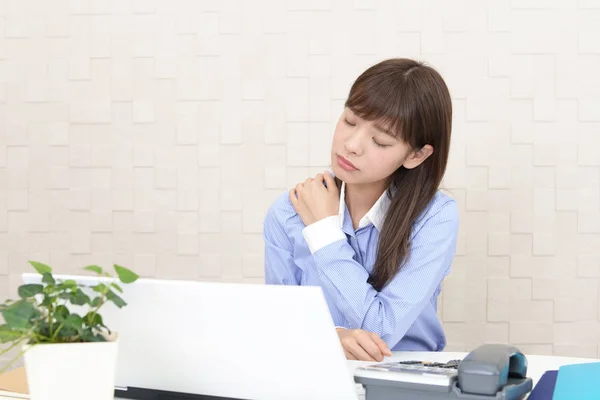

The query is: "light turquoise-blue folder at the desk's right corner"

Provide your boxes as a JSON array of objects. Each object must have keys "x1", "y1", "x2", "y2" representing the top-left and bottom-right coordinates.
[{"x1": 552, "y1": 362, "x2": 600, "y2": 400}]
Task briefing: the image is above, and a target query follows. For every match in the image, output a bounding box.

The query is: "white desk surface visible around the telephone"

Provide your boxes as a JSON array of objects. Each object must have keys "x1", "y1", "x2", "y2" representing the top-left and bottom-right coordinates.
[{"x1": 0, "y1": 352, "x2": 600, "y2": 400}]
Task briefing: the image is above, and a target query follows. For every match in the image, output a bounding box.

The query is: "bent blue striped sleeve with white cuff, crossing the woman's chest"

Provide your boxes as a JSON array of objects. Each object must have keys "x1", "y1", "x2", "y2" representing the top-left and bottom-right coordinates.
[{"x1": 303, "y1": 200, "x2": 458, "y2": 347}]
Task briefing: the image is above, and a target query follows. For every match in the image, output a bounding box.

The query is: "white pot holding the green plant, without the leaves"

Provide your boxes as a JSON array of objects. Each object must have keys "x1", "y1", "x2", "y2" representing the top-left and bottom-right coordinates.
[{"x1": 23, "y1": 335, "x2": 119, "y2": 400}]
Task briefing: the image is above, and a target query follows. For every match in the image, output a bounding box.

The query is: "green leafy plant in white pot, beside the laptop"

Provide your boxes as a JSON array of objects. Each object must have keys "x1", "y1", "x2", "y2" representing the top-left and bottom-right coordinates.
[{"x1": 0, "y1": 261, "x2": 138, "y2": 400}]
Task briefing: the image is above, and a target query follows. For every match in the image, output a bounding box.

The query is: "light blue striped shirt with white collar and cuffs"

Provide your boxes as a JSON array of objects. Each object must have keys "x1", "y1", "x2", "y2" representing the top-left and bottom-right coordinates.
[{"x1": 263, "y1": 184, "x2": 459, "y2": 351}]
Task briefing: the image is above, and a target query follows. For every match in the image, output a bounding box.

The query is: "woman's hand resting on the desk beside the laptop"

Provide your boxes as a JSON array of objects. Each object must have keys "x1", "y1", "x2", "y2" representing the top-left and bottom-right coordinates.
[{"x1": 336, "y1": 328, "x2": 392, "y2": 362}]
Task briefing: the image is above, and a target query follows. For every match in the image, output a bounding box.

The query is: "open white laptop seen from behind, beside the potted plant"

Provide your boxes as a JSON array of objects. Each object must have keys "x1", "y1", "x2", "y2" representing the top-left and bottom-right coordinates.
[{"x1": 23, "y1": 273, "x2": 357, "y2": 400}]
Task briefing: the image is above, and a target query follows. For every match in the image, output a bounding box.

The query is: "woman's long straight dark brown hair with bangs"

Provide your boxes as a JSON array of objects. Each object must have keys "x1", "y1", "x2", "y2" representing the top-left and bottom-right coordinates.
[{"x1": 345, "y1": 58, "x2": 452, "y2": 291}]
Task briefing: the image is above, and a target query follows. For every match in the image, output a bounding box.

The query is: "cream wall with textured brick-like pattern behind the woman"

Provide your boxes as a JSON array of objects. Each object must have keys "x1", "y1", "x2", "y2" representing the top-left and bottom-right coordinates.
[{"x1": 0, "y1": 0, "x2": 600, "y2": 357}]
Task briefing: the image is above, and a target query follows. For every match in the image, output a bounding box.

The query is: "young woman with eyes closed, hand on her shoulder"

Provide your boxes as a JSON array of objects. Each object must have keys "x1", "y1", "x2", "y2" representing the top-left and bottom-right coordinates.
[{"x1": 264, "y1": 59, "x2": 459, "y2": 361}]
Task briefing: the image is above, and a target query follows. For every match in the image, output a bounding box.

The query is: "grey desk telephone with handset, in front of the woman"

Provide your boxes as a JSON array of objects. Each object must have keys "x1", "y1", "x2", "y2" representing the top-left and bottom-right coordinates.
[{"x1": 354, "y1": 344, "x2": 533, "y2": 400}]
